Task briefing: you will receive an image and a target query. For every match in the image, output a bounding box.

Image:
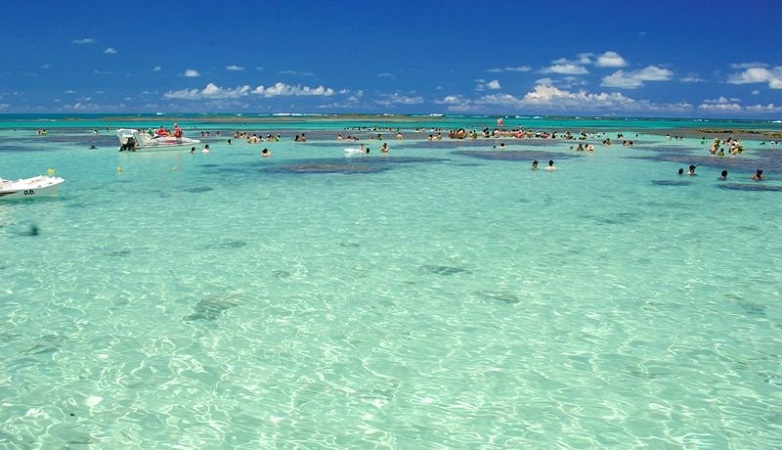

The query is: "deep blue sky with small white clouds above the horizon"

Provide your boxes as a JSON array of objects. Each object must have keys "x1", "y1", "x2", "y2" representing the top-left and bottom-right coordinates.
[{"x1": 0, "y1": 0, "x2": 782, "y2": 119}]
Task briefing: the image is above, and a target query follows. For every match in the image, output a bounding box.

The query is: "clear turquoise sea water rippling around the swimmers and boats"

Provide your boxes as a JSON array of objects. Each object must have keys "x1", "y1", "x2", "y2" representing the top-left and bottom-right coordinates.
[{"x1": 0, "y1": 118, "x2": 782, "y2": 449}]
